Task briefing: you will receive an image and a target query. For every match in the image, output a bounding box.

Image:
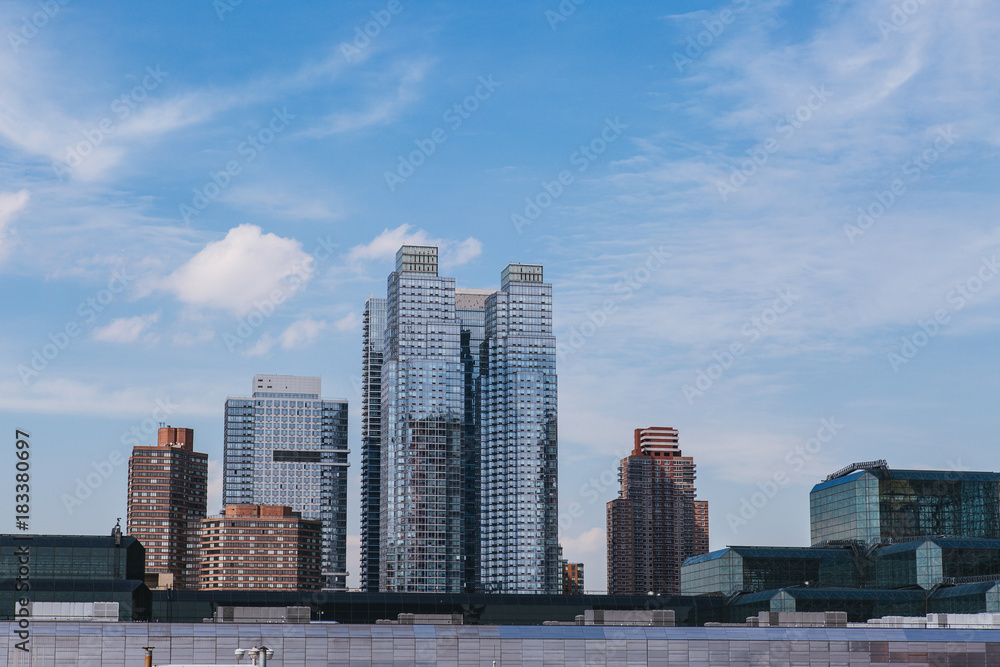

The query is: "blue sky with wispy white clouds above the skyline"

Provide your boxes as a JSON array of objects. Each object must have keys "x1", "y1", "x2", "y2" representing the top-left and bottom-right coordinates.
[{"x1": 0, "y1": 0, "x2": 1000, "y2": 590}]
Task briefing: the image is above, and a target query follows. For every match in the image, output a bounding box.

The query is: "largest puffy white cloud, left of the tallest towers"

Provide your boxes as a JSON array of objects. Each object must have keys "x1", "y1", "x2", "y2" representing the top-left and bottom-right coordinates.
[{"x1": 161, "y1": 225, "x2": 310, "y2": 316}]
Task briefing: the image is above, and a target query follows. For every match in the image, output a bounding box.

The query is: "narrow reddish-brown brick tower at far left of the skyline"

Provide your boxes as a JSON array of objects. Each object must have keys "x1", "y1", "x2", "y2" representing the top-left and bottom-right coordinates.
[{"x1": 126, "y1": 426, "x2": 208, "y2": 589}]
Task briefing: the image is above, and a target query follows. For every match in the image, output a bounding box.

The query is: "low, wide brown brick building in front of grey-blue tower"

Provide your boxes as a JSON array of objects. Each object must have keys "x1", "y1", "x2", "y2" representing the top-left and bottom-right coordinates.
[{"x1": 197, "y1": 505, "x2": 323, "y2": 590}]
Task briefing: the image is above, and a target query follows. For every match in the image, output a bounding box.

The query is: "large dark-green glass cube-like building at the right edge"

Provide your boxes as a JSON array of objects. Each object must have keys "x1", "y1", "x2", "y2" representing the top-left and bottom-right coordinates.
[{"x1": 809, "y1": 460, "x2": 1000, "y2": 545}]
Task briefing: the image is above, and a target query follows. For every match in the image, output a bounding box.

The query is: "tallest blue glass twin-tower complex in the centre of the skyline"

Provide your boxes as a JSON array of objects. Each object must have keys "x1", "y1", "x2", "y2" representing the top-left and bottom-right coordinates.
[{"x1": 361, "y1": 246, "x2": 561, "y2": 593}]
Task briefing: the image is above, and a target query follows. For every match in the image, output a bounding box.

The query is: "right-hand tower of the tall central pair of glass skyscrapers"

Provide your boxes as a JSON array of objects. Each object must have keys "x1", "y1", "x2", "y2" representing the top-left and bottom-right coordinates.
[{"x1": 480, "y1": 264, "x2": 562, "y2": 593}]
